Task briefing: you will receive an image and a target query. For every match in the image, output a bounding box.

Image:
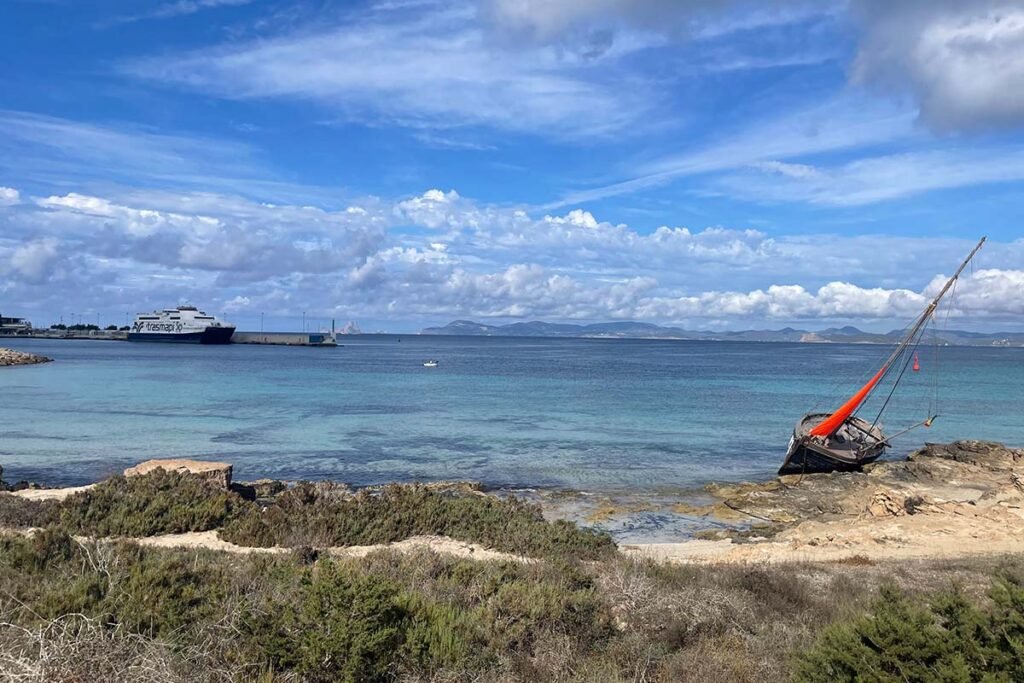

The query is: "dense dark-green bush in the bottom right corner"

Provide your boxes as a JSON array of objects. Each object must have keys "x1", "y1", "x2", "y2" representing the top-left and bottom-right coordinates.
[{"x1": 796, "y1": 575, "x2": 1024, "y2": 683}]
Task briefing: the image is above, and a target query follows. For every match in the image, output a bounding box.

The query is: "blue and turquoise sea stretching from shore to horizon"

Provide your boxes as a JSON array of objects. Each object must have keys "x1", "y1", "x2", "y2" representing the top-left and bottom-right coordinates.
[{"x1": 0, "y1": 335, "x2": 1024, "y2": 492}]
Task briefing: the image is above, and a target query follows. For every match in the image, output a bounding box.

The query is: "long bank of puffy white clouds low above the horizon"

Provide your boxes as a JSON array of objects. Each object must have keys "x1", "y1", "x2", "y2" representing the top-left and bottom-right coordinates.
[{"x1": 0, "y1": 185, "x2": 1024, "y2": 326}]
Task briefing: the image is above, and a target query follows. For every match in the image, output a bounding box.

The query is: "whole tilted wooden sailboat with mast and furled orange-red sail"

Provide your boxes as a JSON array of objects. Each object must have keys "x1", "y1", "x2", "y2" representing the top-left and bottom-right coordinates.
[{"x1": 778, "y1": 238, "x2": 985, "y2": 474}]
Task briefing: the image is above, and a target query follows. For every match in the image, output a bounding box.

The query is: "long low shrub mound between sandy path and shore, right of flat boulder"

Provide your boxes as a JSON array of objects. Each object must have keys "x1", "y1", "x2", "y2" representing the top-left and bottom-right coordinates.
[{"x1": 221, "y1": 484, "x2": 614, "y2": 559}]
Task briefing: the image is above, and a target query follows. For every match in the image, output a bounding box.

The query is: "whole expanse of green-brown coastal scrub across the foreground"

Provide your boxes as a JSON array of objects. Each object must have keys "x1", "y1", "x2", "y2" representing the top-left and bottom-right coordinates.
[{"x1": 0, "y1": 470, "x2": 1024, "y2": 683}]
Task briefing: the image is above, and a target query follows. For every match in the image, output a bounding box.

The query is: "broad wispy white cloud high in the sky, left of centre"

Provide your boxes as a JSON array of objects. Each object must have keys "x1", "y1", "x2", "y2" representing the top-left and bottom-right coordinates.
[{"x1": 125, "y1": 5, "x2": 654, "y2": 136}]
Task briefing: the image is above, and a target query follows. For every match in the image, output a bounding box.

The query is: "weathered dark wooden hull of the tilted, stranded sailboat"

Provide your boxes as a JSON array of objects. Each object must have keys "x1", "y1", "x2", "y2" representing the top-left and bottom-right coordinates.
[{"x1": 778, "y1": 414, "x2": 889, "y2": 475}]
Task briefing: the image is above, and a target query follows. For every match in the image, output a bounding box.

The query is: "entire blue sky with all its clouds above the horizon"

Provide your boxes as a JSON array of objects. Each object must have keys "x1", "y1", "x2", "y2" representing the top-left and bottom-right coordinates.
[{"x1": 0, "y1": 0, "x2": 1024, "y2": 333}]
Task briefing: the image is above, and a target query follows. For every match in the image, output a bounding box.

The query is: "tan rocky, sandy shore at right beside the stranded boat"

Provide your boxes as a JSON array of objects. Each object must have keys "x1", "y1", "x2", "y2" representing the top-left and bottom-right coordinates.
[{"x1": 623, "y1": 441, "x2": 1024, "y2": 562}]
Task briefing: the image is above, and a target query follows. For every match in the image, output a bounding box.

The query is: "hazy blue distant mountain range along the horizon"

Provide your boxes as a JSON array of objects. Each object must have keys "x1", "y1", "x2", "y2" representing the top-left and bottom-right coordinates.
[{"x1": 420, "y1": 321, "x2": 1024, "y2": 346}]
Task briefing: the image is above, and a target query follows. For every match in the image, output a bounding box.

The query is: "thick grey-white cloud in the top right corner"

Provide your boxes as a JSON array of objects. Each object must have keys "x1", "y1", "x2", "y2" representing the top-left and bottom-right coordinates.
[{"x1": 853, "y1": 0, "x2": 1024, "y2": 130}]
